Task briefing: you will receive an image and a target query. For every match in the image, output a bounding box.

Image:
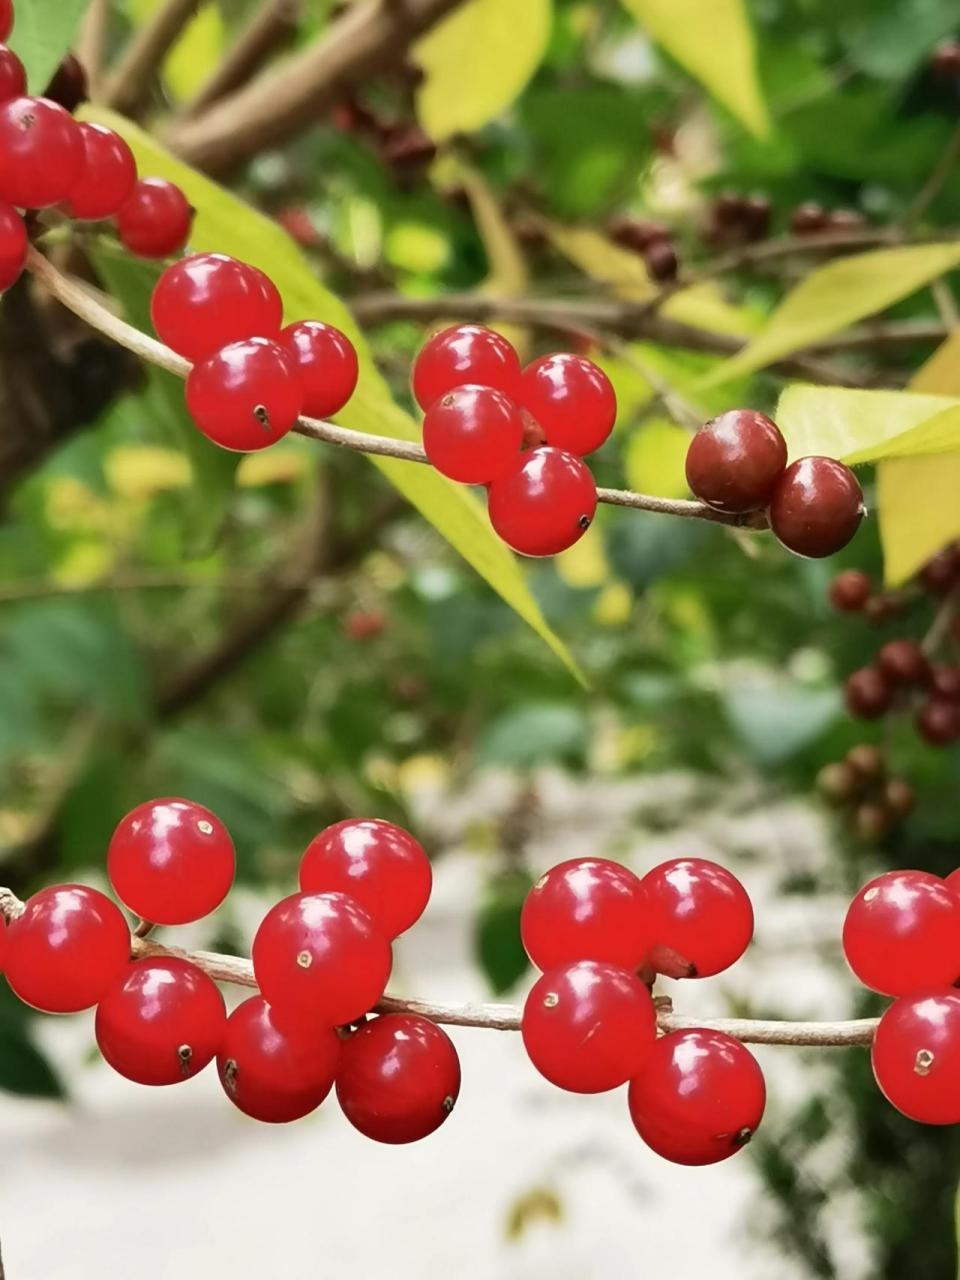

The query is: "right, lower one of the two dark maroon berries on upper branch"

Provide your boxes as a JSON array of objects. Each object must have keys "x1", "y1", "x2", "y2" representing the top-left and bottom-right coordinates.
[{"x1": 769, "y1": 457, "x2": 864, "y2": 559}]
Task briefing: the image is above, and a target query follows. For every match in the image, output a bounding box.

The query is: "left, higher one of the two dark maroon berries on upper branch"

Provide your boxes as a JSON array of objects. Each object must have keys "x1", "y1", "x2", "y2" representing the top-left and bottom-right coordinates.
[{"x1": 686, "y1": 408, "x2": 787, "y2": 512}]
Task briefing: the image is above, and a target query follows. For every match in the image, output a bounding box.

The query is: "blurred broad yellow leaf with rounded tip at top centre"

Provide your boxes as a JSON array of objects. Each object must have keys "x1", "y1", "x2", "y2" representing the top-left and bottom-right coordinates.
[{"x1": 413, "y1": 0, "x2": 553, "y2": 142}]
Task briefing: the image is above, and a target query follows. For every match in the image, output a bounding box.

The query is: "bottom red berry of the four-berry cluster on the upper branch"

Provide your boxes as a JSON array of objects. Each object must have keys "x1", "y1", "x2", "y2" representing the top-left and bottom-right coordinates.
[{"x1": 488, "y1": 448, "x2": 596, "y2": 556}]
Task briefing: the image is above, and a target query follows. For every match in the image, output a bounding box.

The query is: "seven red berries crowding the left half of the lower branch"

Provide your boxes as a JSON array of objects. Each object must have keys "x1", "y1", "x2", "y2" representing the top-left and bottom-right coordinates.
[{"x1": 0, "y1": 799, "x2": 460, "y2": 1143}]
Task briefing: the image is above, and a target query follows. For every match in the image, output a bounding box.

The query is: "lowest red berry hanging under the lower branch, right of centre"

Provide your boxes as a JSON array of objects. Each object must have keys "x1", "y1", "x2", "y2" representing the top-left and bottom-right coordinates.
[{"x1": 628, "y1": 1030, "x2": 767, "y2": 1165}]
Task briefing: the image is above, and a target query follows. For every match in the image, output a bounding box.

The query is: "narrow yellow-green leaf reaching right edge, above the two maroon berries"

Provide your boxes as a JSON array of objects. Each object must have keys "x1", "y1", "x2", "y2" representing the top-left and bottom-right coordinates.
[{"x1": 705, "y1": 244, "x2": 960, "y2": 385}]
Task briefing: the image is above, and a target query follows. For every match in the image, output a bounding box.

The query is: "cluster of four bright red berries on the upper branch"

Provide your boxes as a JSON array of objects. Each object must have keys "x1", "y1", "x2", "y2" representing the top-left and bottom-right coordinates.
[{"x1": 413, "y1": 324, "x2": 617, "y2": 556}]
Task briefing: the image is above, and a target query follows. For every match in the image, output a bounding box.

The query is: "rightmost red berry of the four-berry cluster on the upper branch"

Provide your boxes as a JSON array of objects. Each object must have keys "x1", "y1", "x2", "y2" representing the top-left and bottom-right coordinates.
[{"x1": 521, "y1": 352, "x2": 617, "y2": 457}]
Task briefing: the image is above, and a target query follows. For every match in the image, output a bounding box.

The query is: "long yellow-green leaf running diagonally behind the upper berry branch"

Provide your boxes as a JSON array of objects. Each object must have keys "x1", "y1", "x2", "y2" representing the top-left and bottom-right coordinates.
[{"x1": 83, "y1": 106, "x2": 582, "y2": 680}]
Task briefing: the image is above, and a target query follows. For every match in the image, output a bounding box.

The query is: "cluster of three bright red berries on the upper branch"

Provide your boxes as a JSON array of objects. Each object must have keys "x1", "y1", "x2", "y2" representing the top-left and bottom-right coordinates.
[{"x1": 151, "y1": 253, "x2": 358, "y2": 452}]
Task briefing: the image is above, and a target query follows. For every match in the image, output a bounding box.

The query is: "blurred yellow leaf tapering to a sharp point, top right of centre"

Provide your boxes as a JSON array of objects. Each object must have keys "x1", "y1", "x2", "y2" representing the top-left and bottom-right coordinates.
[{"x1": 623, "y1": 0, "x2": 771, "y2": 137}]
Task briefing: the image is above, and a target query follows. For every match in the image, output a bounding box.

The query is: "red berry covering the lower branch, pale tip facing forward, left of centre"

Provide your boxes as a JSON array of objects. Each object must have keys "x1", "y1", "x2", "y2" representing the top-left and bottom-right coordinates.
[{"x1": 253, "y1": 893, "x2": 392, "y2": 1027}]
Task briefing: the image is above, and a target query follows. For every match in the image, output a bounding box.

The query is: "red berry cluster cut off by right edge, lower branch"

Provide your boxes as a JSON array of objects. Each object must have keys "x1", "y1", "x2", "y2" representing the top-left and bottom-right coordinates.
[{"x1": 844, "y1": 870, "x2": 960, "y2": 1124}]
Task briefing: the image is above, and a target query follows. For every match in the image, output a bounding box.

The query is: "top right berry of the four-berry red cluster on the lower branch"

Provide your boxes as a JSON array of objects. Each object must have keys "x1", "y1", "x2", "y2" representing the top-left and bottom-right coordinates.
[{"x1": 643, "y1": 858, "x2": 754, "y2": 978}]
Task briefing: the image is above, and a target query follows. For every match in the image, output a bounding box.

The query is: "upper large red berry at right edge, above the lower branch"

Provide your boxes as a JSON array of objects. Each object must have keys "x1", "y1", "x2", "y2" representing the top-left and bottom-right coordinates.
[{"x1": 844, "y1": 872, "x2": 960, "y2": 996}]
